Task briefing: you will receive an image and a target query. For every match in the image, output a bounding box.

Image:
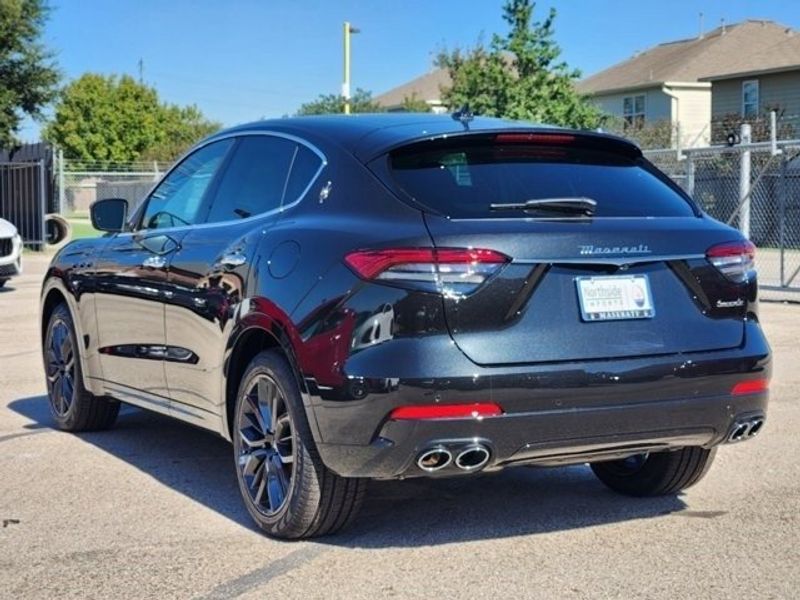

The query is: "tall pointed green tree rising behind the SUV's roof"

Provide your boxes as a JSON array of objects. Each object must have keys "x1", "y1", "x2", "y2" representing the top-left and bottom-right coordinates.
[{"x1": 437, "y1": 0, "x2": 600, "y2": 128}]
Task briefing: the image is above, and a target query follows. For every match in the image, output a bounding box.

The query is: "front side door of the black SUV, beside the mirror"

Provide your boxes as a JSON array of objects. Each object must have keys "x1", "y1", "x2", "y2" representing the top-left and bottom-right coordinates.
[{"x1": 95, "y1": 140, "x2": 233, "y2": 411}]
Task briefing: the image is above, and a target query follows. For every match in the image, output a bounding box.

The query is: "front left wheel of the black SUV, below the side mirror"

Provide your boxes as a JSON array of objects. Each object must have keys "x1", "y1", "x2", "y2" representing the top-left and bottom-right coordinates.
[{"x1": 44, "y1": 304, "x2": 119, "y2": 432}]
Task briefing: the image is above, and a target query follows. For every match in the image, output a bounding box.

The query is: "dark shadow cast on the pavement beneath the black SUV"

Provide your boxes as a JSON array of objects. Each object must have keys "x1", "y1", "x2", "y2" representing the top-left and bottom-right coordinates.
[{"x1": 10, "y1": 396, "x2": 686, "y2": 548}]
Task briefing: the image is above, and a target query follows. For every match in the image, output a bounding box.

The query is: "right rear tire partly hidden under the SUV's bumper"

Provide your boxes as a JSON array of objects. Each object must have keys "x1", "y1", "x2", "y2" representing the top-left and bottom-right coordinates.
[{"x1": 591, "y1": 447, "x2": 717, "y2": 496}]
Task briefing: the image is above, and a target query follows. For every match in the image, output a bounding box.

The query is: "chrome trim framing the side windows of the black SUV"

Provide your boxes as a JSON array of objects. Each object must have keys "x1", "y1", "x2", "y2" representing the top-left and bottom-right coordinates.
[{"x1": 126, "y1": 129, "x2": 328, "y2": 236}]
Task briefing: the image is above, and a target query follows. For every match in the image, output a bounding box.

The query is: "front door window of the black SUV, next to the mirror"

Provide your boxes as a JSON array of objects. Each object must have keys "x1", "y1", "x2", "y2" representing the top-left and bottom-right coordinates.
[{"x1": 142, "y1": 140, "x2": 233, "y2": 229}]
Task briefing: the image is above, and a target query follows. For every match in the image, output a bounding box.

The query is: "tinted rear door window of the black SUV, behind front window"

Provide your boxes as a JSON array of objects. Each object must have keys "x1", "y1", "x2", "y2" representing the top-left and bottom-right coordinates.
[{"x1": 207, "y1": 135, "x2": 297, "y2": 223}]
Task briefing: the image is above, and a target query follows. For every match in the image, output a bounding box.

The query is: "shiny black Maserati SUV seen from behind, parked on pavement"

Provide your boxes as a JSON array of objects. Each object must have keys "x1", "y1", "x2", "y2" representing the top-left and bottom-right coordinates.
[{"x1": 42, "y1": 114, "x2": 770, "y2": 538}]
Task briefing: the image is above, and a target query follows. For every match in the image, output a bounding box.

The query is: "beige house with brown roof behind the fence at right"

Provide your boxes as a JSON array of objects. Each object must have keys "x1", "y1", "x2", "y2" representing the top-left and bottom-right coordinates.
[{"x1": 578, "y1": 20, "x2": 800, "y2": 147}]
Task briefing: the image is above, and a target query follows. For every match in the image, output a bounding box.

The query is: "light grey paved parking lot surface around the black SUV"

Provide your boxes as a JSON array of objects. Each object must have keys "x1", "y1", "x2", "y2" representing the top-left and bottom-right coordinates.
[{"x1": 0, "y1": 255, "x2": 800, "y2": 599}]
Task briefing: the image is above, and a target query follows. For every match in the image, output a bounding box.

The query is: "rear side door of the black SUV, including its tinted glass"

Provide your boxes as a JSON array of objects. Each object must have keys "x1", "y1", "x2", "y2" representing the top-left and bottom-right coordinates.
[{"x1": 165, "y1": 134, "x2": 323, "y2": 429}]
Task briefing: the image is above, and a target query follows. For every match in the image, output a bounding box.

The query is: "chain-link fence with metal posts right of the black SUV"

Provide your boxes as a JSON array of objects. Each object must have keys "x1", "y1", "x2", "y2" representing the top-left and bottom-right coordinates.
[{"x1": 645, "y1": 140, "x2": 800, "y2": 301}]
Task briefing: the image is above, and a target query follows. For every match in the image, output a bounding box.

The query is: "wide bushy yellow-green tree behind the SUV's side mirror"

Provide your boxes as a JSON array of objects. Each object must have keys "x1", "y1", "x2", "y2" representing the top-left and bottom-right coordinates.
[{"x1": 44, "y1": 73, "x2": 219, "y2": 163}]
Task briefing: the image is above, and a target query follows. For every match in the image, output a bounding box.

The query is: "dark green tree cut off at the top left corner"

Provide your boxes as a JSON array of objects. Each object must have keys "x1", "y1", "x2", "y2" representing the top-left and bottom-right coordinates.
[{"x1": 0, "y1": 0, "x2": 59, "y2": 148}]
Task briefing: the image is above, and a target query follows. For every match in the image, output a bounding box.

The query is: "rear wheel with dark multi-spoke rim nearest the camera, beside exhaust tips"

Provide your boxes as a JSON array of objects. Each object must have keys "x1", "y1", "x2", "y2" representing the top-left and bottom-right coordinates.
[{"x1": 232, "y1": 350, "x2": 366, "y2": 539}]
